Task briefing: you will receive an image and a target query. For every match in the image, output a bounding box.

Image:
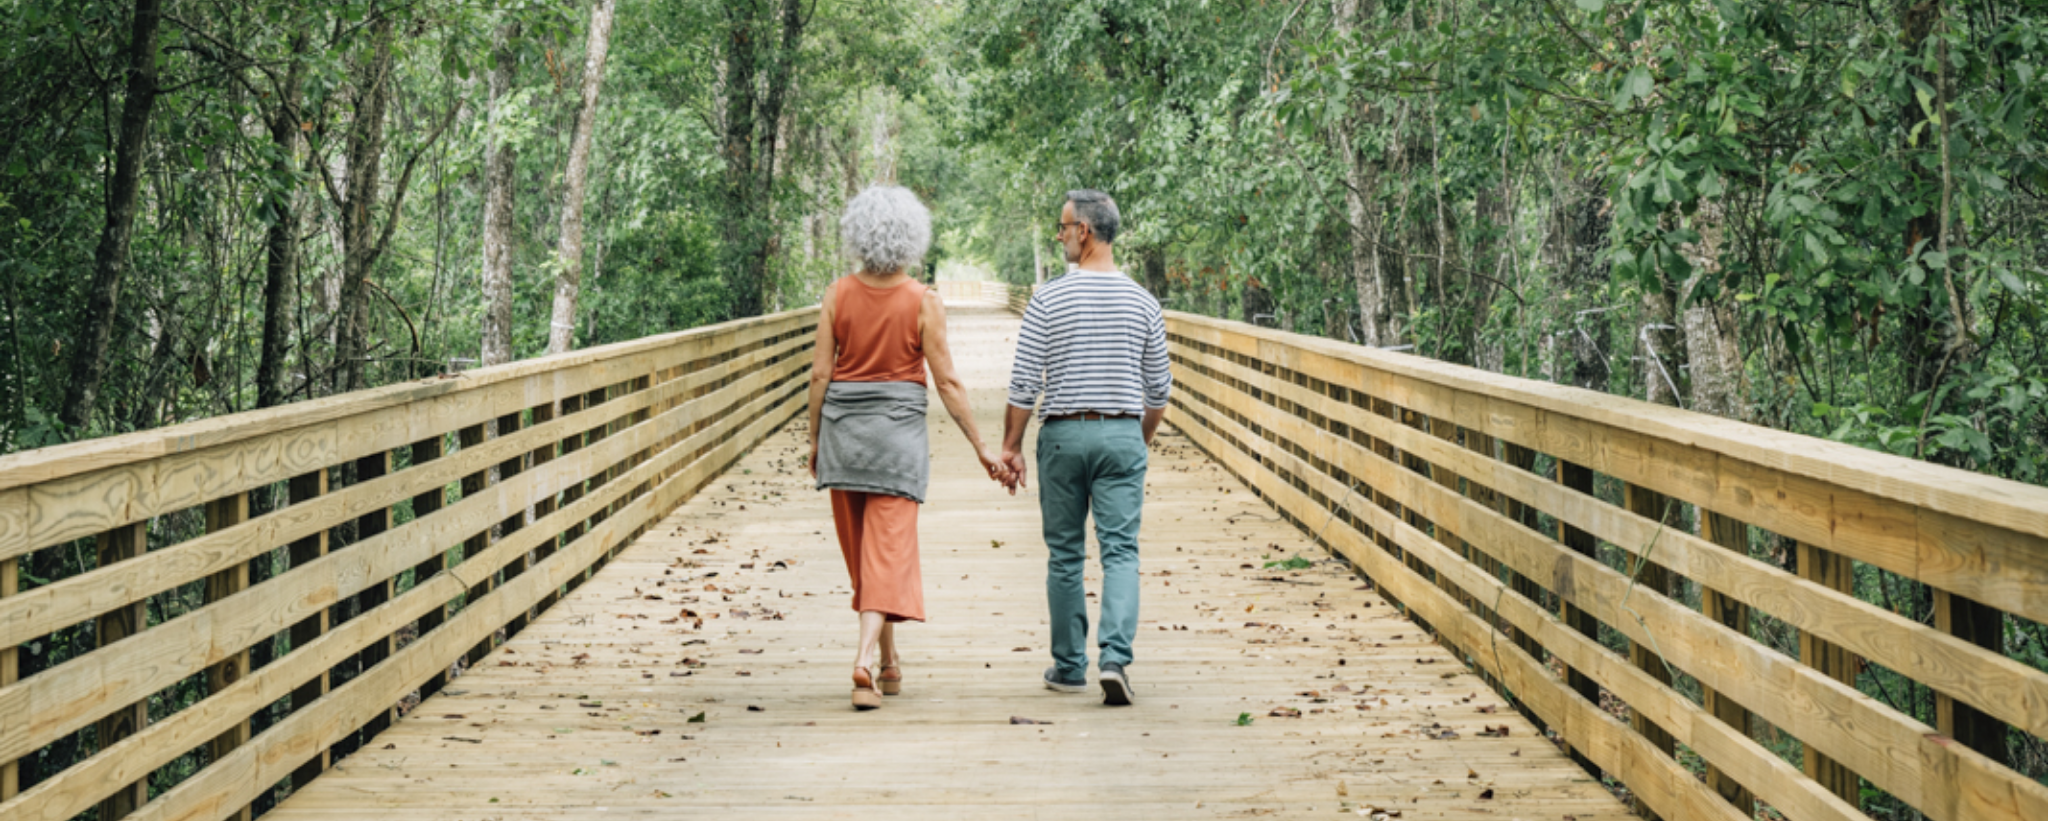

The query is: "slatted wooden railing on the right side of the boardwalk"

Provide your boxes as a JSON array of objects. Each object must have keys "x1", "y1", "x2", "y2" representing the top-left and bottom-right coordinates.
[{"x1": 1167, "y1": 313, "x2": 2048, "y2": 821}]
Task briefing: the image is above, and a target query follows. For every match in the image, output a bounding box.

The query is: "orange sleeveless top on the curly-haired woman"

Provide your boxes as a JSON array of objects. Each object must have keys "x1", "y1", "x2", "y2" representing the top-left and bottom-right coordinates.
[{"x1": 831, "y1": 276, "x2": 926, "y2": 385}]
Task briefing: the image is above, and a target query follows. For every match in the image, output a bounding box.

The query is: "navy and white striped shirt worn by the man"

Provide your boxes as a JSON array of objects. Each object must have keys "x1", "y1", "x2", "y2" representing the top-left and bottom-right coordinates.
[{"x1": 1010, "y1": 270, "x2": 1174, "y2": 420}]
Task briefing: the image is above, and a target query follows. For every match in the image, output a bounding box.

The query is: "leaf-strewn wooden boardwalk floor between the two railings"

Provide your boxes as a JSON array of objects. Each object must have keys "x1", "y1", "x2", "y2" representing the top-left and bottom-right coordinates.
[{"x1": 270, "y1": 305, "x2": 1630, "y2": 821}]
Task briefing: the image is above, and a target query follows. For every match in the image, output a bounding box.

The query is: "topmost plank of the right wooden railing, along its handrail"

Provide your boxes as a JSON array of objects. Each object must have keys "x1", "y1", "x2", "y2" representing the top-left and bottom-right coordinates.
[{"x1": 1169, "y1": 315, "x2": 2048, "y2": 620}]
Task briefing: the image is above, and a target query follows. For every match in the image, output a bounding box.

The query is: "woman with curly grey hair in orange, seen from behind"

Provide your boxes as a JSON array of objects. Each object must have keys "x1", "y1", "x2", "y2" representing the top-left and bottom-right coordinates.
[{"x1": 811, "y1": 186, "x2": 1010, "y2": 710}]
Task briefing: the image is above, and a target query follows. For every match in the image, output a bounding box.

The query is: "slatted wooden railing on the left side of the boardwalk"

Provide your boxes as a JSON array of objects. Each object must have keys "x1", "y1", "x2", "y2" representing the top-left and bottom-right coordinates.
[{"x1": 0, "y1": 309, "x2": 817, "y2": 821}]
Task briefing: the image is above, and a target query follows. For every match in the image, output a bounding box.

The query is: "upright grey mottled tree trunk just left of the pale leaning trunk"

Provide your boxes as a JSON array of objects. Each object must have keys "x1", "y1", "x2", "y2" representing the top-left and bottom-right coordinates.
[{"x1": 479, "y1": 23, "x2": 524, "y2": 366}]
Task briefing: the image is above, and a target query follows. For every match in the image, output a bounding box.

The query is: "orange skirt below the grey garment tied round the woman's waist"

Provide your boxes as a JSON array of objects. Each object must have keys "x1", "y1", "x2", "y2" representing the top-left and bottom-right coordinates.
[{"x1": 831, "y1": 489, "x2": 924, "y2": 622}]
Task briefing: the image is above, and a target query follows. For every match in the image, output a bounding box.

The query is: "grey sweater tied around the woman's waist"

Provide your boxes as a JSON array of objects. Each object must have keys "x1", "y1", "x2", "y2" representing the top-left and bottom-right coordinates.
[{"x1": 817, "y1": 383, "x2": 932, "y2": 504}]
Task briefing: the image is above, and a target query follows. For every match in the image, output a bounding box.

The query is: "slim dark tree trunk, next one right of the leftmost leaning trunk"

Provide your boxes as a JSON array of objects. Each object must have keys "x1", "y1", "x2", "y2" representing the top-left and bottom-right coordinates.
[{"x1": 256, "y1": 33, "x2": 307, "y2": 407}]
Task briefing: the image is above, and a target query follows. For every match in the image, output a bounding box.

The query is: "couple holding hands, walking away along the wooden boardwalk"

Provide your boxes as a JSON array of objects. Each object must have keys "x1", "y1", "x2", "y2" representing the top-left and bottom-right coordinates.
[{"x1": 811, "y1": 186, "x2": 1171, "y2": 710}]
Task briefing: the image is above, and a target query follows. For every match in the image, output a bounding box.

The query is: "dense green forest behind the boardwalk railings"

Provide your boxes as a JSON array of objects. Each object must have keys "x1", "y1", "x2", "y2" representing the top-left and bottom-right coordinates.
[{"x1": 0, "y1": 0, "x2": 2048, "y2": 819}]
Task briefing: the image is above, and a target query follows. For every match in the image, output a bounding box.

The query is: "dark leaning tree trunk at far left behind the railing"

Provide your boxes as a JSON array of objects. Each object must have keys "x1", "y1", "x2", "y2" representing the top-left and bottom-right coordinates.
[{"x1": 57, "y1": 0, "x2": 164, "y2": 436}]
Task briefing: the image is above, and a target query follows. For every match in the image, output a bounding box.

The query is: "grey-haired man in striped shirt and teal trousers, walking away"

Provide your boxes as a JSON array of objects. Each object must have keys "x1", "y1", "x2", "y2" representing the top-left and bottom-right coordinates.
[{"x1": 1004, "y1": 190, "x2": 1174, "y2": 704}]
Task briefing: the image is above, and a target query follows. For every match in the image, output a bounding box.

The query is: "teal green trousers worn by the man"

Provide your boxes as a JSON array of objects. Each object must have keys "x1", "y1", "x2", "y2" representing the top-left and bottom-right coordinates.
[{"x1": 1038, "y1": 420, "x2": 1147, "y2": 678}]
